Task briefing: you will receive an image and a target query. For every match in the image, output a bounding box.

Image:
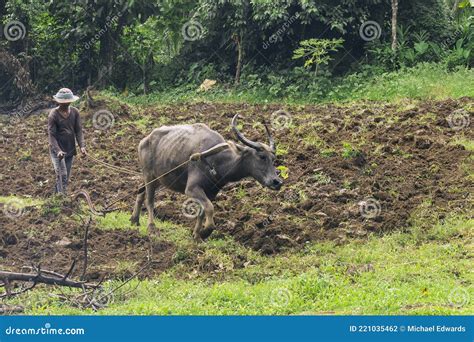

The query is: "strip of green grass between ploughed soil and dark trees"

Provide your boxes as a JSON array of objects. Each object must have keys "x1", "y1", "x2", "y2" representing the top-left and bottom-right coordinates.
[{"x1": 104, "y1": 63, "x2": 474, "y2": 107}]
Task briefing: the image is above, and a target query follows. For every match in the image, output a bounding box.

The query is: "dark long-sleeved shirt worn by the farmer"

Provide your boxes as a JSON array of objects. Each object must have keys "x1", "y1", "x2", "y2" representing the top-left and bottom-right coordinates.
[{"x1": 48, "y1": 107, "x2": 85, "y2": 157}]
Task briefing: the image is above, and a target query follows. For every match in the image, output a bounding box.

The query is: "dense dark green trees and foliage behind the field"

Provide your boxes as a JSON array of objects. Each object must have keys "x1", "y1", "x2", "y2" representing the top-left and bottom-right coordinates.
[{"x1": 0, "y1": 0, "x2": 474, "y2": 101}]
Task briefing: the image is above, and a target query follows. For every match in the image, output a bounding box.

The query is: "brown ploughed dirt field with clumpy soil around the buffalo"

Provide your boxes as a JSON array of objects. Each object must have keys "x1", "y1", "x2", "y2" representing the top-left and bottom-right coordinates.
[{"x1": 0, "y1": 98, "x2": 474, "y2": 279}]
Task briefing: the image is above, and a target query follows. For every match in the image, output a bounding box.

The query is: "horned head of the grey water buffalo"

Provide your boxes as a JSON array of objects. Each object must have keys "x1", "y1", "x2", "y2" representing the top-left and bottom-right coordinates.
[{"x1": 232, "y1": 114, "x2": 283, "y2": 190}]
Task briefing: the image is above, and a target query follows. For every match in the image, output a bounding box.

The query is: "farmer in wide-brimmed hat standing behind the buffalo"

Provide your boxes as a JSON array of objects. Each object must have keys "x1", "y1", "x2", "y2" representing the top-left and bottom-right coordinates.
[{"x1": 48, "y1": 88, "x2": 87, "y2": 194}]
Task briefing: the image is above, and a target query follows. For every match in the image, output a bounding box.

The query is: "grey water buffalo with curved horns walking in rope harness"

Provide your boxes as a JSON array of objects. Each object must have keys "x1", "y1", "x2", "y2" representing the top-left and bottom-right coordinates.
[{"x1": 130, "y1": 114, "x2": 283, "y2": 241}]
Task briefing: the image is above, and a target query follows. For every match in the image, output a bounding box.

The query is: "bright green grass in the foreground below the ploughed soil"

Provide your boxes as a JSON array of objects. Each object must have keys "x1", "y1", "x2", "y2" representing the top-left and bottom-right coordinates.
[{"x1": 4, "y1": 213, "x2": 474, "y2": 315}]
